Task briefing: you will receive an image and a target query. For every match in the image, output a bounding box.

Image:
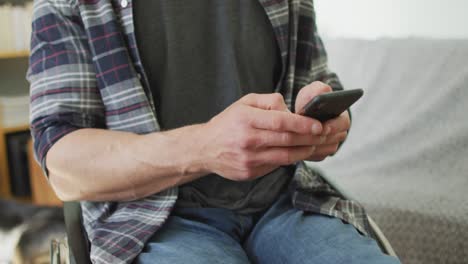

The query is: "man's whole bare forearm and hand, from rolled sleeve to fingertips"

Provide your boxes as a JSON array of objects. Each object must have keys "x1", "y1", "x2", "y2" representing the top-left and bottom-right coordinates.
[{"x1": 47, "y1": 94, "x2": 330, "y2": 201}]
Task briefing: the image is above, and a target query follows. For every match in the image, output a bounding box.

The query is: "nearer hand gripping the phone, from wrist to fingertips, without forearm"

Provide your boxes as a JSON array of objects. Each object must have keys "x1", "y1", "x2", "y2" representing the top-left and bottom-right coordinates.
[{"x1": 198, "y1": 93, "x2": 326, "y2": 181}]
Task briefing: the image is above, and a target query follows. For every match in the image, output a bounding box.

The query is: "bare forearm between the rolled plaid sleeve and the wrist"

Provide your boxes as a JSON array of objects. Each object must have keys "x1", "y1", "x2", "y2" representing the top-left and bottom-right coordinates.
[{"x1": 47, "y1": 125, "x2": 207, "y2": 201}]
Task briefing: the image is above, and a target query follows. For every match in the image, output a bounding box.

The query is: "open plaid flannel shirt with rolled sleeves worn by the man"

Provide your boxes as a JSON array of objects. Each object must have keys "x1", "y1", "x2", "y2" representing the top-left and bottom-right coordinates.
[{"x1": 28, "y1": 0, "x2": 369, "y2": 263}]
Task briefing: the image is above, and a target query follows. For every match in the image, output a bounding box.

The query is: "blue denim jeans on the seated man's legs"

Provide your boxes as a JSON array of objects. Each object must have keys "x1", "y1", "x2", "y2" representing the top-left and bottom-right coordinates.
[{"x1": 136, "y1": 194, "x2": 400, "y2": 264}]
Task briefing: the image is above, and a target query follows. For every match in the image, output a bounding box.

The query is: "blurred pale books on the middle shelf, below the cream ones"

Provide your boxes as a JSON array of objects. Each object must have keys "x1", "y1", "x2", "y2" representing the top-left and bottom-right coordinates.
[{"x1": 0, "y1": 95, "x2": 29, "y2": 128}]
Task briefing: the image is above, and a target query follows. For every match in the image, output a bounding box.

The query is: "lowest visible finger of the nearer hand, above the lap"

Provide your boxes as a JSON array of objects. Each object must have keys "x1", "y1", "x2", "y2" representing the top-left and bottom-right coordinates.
[{"x1": 256, "y1": 146, "x2": 315, "y2": 166}]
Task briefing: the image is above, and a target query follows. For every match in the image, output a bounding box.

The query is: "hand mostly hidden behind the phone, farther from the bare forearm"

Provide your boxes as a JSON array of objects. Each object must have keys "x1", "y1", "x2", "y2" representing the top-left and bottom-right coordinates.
[{"x1": 295, "y1": 82, "x2": 351, "y2": 161}]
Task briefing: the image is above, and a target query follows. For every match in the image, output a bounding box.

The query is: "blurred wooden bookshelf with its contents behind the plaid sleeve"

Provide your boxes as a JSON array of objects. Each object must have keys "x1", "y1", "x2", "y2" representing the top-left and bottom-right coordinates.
[{"x1": 0, "y1": 0, "x2": 61, "y2": 205}]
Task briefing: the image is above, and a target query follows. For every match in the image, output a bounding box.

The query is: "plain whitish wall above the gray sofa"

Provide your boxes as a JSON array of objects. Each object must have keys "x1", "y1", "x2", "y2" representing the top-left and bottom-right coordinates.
[{"x1": 314, "y1": 0, "x2": 468, "y2": 38}]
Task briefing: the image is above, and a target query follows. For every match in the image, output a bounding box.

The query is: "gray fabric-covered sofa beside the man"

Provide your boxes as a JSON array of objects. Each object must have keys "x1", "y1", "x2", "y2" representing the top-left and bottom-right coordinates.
[{"x1": 312, "y1": 39, "x2": 468, "y2": 264}]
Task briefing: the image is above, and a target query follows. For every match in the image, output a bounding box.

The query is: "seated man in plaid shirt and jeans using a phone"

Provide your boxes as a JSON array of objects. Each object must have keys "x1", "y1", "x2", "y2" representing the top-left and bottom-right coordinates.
[{"x1": 28, "y1": 0, "x2": 398, "y2": 263}]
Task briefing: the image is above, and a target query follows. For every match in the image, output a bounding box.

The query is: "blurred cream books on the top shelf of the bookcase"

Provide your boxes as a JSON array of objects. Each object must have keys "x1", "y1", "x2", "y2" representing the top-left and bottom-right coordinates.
[{"x1": 0, "y1": 2, "x2": 32, "y2": 52}]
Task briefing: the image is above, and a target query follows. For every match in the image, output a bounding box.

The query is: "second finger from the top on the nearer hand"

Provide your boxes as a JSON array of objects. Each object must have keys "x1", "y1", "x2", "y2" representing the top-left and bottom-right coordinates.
[{"x1": 249, "y1": 129, "x2": 326, "y2": 149}]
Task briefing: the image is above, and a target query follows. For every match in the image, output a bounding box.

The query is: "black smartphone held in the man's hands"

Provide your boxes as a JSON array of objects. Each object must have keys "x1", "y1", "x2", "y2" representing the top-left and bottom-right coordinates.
[{"x1": 299, "y1": 89, "x2": 364, "y2": 122}]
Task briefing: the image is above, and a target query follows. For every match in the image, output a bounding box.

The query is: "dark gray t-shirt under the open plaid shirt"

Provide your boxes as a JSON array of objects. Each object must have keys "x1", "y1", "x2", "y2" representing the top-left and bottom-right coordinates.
[{"x1": 133, "y1": 0, "x2": 291, "y2": 213}]
